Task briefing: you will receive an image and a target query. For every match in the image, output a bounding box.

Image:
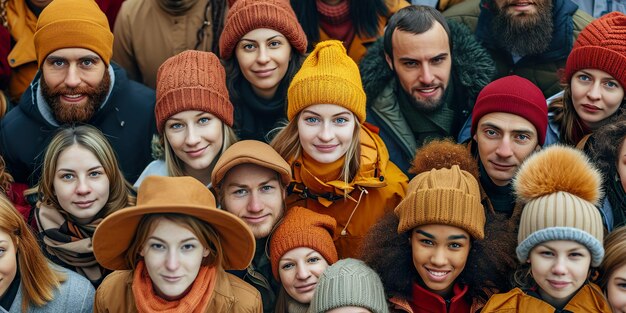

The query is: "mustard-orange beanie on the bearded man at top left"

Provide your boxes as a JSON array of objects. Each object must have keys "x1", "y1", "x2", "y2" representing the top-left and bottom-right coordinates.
[{"x1": 34, "y1": 0, "x2": 113, "y2": 67}]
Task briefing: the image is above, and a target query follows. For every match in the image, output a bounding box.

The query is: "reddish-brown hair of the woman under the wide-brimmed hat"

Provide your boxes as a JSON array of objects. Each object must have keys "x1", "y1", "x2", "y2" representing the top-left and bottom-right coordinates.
[{"x1": 126, "y1": 213, "x2": 224, "y2": 270}]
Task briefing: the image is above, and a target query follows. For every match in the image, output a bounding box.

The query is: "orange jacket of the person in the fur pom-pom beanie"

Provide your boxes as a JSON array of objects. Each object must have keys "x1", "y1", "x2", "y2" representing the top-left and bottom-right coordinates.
[{"x1": 481, "y1": 283, "x2": 611, "y2": 313}]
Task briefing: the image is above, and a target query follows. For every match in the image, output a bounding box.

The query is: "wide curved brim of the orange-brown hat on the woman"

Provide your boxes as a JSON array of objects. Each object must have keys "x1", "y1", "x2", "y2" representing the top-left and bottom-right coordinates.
[{"x1": 93, "y1": 204, "x2": 256, "y2": 270}]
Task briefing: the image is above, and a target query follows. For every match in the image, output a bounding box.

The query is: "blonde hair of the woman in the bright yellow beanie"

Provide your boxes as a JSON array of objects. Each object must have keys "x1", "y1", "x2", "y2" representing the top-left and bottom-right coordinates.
[{"x1": 270, "y1": 111, "x2": 361, "y2": 183}]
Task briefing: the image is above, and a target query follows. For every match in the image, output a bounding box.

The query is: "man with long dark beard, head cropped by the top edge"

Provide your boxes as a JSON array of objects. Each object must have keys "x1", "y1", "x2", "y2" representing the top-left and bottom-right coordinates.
[{"x1": 443, "y1": 0, "x2": 593, "y2": 98}]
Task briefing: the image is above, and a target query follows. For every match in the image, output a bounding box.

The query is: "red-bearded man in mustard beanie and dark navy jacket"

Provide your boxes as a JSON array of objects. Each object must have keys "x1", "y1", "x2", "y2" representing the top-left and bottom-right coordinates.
[{"x1": 0, "y1": 0, "x2": 156, "y2": 186}]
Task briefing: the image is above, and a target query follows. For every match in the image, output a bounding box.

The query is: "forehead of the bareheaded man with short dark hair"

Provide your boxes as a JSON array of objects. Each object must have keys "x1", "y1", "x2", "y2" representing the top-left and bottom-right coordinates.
[{"x1": 391, "y1": 22, "x2": 450, "y2": 60}]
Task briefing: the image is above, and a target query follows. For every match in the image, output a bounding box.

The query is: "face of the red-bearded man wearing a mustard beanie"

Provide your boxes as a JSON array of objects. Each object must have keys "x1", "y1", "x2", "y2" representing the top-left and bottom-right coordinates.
[{"x1": 41, "y1": 48, "x2": 111, "y2": 123}]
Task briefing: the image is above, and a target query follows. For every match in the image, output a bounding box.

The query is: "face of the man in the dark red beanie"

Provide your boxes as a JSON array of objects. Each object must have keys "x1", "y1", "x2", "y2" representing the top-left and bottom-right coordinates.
[{"x1": 474, "y1": 112, "x2": 539, "y2": 186}]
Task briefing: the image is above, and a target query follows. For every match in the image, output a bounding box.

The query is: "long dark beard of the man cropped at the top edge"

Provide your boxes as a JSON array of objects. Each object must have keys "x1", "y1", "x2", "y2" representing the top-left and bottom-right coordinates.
[{"x1": 491, "y1": 0, "x2": 554, "y2": 56}]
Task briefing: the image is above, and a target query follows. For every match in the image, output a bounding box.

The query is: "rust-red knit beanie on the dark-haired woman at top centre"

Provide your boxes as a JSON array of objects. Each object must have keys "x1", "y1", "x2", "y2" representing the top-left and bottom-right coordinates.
[{"x1": 220, "y1": 0, "x2": 307, "y2": 60}]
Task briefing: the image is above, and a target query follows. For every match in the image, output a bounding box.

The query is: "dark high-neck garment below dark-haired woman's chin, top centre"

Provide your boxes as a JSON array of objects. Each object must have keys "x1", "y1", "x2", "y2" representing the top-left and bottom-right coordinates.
[{"x1": 235, "y1": 79, "x2": 287, "y2": 142}]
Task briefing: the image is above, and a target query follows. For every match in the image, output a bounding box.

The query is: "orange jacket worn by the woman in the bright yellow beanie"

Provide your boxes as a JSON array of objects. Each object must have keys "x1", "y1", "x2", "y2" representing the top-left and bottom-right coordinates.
[{"x1": 285, "y1": 126, "x2": 408, "y2": 259}]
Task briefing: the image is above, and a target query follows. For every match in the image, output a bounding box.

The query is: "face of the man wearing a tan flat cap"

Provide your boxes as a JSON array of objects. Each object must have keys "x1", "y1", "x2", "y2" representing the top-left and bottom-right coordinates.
[{"x1": 220, "y1": 163, "x2": 285, "y2": 239}]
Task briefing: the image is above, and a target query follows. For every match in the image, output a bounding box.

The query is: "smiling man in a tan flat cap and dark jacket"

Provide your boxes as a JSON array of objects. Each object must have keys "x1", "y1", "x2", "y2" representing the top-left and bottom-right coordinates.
[{"x1": 211, "y1": 140, "x2": 291, "y2": 313}]
